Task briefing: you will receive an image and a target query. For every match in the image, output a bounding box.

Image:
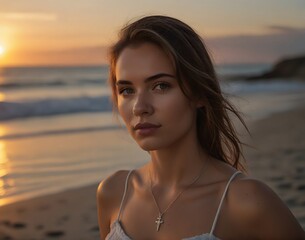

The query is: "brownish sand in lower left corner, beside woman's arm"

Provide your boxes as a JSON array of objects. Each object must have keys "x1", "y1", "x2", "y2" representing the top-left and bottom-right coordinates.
[{"x1": 0, "y1": 184, "x2": 99, "y2": 240}]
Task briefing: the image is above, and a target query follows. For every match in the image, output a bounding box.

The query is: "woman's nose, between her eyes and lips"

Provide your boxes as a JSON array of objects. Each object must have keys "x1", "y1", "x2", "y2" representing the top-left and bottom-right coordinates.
[{"x1": 132, "y1": 93, "x2": 154, "y2": 116}]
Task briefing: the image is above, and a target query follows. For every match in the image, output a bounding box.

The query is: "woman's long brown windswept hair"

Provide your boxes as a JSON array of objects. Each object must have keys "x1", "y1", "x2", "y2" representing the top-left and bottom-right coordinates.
[{"x1": 109, "y1": 15, "x2": 248, "y2": 170}]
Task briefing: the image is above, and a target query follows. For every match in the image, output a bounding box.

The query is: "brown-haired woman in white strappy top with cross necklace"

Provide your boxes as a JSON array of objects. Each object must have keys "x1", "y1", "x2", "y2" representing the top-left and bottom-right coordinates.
[{"x1": 97, "y1": 16, "x2": 304, "y2": 240}]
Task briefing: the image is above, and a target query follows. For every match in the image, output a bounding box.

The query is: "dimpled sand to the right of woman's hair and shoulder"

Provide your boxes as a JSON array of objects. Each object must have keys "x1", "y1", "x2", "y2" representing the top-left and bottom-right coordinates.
[{"x1": 245, "y1": 106, "x2": 305, "y2": 230}]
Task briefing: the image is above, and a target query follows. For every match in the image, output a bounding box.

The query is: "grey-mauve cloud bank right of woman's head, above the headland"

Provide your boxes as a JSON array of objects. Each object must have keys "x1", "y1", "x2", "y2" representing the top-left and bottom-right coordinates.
[{"x1": 206, "y1": 26, "x2": 305, "y2": 63}]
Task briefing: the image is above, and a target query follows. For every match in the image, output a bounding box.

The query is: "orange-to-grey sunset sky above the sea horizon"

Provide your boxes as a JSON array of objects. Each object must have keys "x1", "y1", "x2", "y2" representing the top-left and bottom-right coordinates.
[{"x1": 0, "y1": 0, "x2": 305, "y2": 67}]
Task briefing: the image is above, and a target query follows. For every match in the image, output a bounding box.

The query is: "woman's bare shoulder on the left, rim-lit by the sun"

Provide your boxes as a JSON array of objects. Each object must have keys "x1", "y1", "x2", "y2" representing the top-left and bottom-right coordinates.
[{"x1": 96, "y1": 170, "x2": 129, "y2": 239}]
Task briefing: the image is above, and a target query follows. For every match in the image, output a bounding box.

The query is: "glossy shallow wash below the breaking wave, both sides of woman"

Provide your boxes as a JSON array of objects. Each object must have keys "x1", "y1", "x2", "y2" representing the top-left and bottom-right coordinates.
[{"x1": 0, "y1": 89, "x2": 305, "y2": 206}]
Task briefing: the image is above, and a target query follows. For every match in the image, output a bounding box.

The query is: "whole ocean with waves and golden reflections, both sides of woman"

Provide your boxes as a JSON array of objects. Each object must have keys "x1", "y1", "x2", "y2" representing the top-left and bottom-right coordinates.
[{"x1": 0, "y1": 64, "x2": 305, "y2": 206}]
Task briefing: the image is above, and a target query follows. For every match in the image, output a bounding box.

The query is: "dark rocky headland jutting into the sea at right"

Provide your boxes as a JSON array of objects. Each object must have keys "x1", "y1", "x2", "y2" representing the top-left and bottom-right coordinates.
[{"x1": 245, "y1": 55, "x2": 305, "y2": 81}]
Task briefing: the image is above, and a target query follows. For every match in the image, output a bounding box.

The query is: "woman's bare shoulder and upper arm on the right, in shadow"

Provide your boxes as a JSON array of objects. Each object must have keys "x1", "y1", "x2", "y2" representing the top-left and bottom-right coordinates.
[{"x1": 227, "y1": 174, "x2": 305, "y2": 239}]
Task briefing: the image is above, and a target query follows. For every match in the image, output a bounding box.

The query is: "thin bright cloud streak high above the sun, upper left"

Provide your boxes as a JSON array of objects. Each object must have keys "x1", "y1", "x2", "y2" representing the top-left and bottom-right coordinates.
[{"x1": 0, "y1": 12, "x2": 57, "y2": 21}]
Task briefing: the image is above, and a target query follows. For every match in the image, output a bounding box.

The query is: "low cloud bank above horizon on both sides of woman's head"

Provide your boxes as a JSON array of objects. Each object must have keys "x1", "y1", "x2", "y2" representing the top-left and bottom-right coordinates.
[{"x1": 7, "y1": 26, "x2": 305, "y2": 65}]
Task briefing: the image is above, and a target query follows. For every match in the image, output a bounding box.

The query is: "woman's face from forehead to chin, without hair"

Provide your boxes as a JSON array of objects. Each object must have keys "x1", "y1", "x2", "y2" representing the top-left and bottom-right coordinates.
[{"x1": 115, "y1": 43, "x2": 196, "y2": 151}]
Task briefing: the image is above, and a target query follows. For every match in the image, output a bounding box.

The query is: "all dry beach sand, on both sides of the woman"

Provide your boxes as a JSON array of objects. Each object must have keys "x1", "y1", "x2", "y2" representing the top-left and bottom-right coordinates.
[{"x1": 0, "y1": 107, "x2": 305, "y2": 240}]
